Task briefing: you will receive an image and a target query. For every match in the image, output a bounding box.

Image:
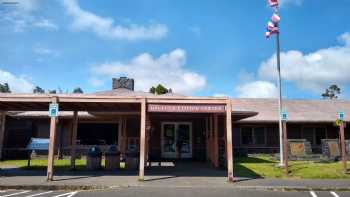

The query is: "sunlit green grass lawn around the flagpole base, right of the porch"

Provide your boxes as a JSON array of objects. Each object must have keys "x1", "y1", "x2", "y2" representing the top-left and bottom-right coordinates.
[{"x1": 234, "y1": 156, "x2": 350, "y2": 179}]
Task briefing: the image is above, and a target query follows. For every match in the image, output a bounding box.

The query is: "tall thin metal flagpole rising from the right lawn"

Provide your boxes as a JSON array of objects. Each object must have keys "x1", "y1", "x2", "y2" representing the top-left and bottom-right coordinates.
[{"x1": 276, "y1": 6, "x2": 284, "y2": 166}]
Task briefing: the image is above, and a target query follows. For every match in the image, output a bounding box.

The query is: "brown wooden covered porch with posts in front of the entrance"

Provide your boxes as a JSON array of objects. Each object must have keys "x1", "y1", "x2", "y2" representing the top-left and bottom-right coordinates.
[{"x1": 0, "y1": 94, "x2": 256, "y2": 181}]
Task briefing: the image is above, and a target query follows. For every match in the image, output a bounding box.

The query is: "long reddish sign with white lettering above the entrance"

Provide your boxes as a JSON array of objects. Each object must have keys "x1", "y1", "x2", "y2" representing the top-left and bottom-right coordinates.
[{"x1": 148, "y1": 104, "x2": 226, "y2": 113}]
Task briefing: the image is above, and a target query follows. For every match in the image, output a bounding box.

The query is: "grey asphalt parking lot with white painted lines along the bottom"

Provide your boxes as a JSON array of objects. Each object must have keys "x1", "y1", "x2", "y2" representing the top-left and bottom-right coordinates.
[{"x1": 0, "y1": 187, "x2": 350, "y2": 197}]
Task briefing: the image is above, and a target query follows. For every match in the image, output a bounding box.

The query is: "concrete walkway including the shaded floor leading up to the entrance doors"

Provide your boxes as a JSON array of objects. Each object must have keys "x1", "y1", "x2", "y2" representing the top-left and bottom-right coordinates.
[{"x1": 0, "y1": 163, "x2": 350, "y2": 191}]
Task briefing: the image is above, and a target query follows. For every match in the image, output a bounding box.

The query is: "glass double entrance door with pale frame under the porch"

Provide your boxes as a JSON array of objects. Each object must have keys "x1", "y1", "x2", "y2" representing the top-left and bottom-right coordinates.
[{"x1": 161, "y1": 122, "x2": 192, "y2": 159}]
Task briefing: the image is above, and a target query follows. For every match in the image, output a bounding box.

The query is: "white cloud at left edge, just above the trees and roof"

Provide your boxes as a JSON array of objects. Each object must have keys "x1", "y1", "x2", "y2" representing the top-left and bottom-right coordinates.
[{"x1": 0, "y1": 69, "x2": 34, "y2": 93}]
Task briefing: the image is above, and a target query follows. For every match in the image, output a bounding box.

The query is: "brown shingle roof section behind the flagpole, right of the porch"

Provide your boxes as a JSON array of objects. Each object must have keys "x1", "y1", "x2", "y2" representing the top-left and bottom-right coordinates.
[{"x1": 232, "y1": 99, "x2": 350, "y2": 122}]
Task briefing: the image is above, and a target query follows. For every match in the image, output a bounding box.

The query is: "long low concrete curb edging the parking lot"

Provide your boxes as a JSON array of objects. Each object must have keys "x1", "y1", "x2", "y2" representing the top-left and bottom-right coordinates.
[{"x1": 0, "y1": 184, "x2": 350, "y2": 192}]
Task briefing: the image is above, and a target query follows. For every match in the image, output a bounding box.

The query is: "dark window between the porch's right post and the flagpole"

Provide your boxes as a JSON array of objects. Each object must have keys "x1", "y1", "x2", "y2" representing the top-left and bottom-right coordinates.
[{"x1": 241, "y1": 127, "x2": 266, "y2": 145}]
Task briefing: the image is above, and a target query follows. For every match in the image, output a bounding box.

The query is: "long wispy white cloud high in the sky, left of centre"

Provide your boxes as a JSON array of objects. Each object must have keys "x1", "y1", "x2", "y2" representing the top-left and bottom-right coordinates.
[{"x1": 63, "y1": 0, "x2": 168, "y2": 40}]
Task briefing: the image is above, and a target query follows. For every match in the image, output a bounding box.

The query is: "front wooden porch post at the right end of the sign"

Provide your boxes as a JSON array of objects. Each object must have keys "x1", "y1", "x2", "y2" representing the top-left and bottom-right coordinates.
[{"x1": 226, "y1": 99, "x2": 234, "y2": 182}]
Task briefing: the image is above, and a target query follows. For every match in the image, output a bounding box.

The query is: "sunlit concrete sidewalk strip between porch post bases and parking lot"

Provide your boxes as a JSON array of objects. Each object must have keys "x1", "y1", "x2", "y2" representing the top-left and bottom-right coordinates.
[{"x1": 0, "y1": 171, "x2": 350, "y2": 191}]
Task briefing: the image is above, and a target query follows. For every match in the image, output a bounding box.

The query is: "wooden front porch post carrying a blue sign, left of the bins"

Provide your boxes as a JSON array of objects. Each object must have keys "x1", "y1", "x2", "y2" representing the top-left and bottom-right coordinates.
[{"x1": 47, "y1": 97, "x2": 58, "y2": 181}]
